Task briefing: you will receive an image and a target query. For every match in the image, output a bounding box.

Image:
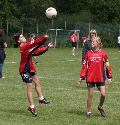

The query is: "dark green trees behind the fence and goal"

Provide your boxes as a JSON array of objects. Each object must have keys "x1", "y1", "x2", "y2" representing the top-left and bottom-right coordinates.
[{"x1": 0, "y1": 0, "x2": 120, "y2": 47}]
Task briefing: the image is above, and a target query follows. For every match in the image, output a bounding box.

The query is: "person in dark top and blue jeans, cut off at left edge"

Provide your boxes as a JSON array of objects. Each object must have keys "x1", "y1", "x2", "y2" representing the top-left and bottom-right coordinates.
[{"x1": 0, "y1": 28, "x2": 7, "y2": 79}]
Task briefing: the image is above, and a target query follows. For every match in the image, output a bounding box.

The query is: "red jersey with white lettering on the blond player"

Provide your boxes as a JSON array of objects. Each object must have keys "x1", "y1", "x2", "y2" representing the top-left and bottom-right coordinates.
[{"x1": 80, "y1": 49, "x2": 108, "y2": 83}]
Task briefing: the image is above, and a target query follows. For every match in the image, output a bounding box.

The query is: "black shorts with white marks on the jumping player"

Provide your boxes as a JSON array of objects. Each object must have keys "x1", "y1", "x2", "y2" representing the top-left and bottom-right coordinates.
[{"x1": 20, "y1": 72, "x2": 35, "y2": 83}]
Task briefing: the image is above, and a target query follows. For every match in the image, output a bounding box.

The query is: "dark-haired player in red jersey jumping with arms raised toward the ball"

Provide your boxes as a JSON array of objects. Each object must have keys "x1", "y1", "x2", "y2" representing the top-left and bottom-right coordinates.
[{"x1": 14, "y1": 34, "x2": 52, "y2": 116}]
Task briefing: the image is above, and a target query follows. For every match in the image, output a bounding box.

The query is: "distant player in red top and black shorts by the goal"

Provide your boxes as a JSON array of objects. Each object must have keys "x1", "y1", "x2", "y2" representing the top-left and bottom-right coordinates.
[{"x1": 70, "y1": 31, "x2": 78, "y2": 56}]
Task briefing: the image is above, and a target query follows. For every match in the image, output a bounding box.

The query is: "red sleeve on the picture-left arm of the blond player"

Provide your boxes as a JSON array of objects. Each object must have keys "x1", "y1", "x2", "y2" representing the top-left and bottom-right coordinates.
[{"x1": 80, "y1": 53, "x2": 87, "y2": 79}]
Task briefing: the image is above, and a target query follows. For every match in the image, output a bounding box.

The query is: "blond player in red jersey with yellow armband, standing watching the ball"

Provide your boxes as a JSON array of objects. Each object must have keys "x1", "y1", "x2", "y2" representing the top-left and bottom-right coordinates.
[{"x1": 79, "y1": 37, "x2": 112, "y2": 117}]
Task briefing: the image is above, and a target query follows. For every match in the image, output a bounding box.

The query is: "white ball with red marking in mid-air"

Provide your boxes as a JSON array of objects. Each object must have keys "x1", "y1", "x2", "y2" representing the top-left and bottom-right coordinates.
[{"x1": 45, "y1": 7, "x2": 57, "y2": 19}]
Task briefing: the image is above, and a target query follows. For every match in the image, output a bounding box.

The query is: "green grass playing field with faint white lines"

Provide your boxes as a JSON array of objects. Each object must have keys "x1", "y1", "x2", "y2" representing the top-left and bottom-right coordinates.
[{"x1": 0, "y1": 48, "x2": 120, "y2": 125}]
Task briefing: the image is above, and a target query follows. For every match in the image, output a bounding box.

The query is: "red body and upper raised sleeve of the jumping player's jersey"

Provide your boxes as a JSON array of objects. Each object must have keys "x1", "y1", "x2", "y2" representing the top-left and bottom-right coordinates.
[{"x1": 19, "y1": 36, "x2": 48, "y2": 72}]
